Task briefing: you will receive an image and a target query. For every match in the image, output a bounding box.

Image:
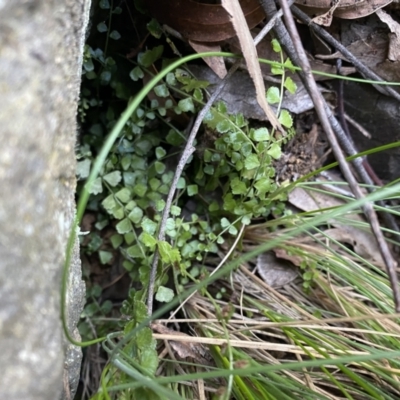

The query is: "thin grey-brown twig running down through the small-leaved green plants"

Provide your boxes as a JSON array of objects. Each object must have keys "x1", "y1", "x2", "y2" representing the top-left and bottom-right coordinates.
[{"x1": 147, "y1": 4, "x2": 294, "y2": 315}]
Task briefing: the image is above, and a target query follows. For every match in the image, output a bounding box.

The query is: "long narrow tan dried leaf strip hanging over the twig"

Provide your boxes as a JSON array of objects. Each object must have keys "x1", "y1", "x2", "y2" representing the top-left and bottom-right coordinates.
[{"x1": 222, "y1": 0, "x2": 284, "y2": 132}]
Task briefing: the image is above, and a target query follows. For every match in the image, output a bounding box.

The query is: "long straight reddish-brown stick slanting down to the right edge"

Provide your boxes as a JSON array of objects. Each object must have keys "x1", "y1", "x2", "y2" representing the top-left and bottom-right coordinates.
[{"x1": 279, "y1": 0, "x2": 400, "y2": 312}]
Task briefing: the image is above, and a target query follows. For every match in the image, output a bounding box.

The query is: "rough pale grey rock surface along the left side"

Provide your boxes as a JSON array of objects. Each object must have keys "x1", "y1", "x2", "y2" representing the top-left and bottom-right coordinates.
[{"x1": 0, "y1": 0, "x2": 90, "y2": 400}]
